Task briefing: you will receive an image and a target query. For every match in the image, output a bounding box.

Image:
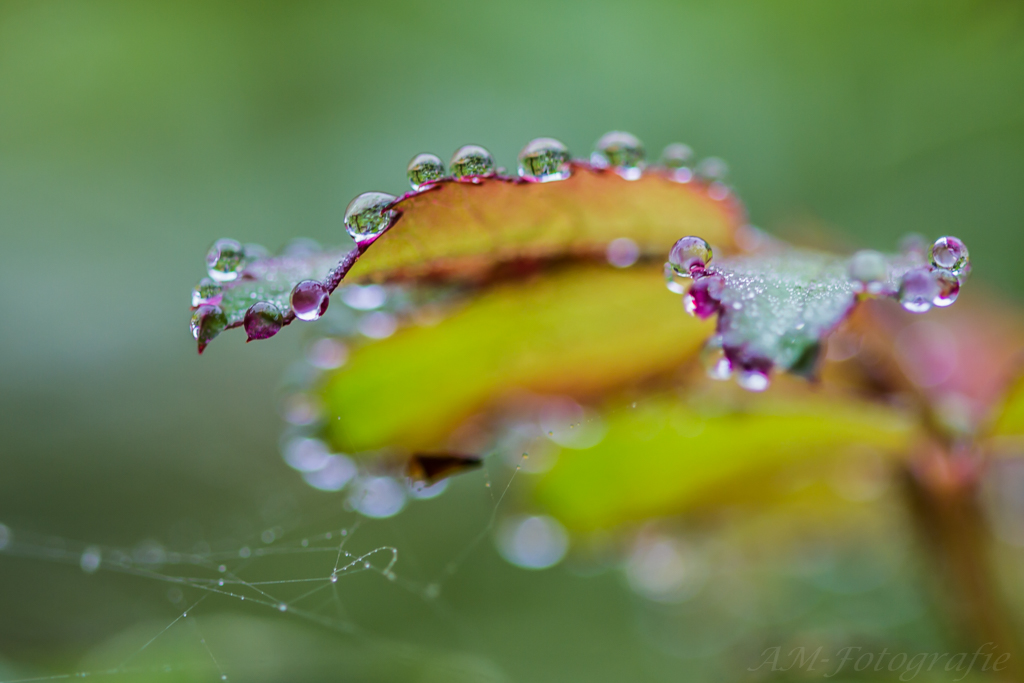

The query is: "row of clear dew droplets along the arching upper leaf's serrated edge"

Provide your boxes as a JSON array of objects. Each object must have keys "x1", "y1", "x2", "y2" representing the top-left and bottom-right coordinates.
[{"x1": 190, "y1": 131, "x2": 728, "y2": 352}]
